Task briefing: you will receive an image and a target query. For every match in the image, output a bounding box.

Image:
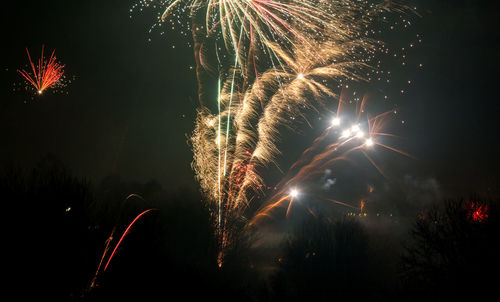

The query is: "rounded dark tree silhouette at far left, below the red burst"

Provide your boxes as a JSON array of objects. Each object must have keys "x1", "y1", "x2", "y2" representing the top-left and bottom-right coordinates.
[{"x1": 0, "y1": 155, "x2": 93, "y2": 300}]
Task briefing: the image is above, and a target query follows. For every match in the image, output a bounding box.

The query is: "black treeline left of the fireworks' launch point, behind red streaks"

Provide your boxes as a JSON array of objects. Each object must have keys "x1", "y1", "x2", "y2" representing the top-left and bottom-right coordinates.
[{"x1": 0, "y1": 156, "x2": 264, "y2": 301}]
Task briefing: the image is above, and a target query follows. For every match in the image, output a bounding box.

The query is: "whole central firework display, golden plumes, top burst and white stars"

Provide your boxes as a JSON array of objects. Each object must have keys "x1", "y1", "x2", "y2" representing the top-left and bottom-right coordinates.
[{"x1": 134, "y1": 0, "x2": 416, "y2": 258}]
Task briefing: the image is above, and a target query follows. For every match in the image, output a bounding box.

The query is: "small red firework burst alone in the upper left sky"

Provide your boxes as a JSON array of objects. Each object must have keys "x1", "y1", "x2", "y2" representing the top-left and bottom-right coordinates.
[{"x1": 17, "y1": 45, "x2": 65, "y2": 94}]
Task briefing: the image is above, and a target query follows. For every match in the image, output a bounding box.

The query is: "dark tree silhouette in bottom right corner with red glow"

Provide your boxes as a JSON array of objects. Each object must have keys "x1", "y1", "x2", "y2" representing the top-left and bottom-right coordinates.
[{"x1": 401, "y1": 198, "x2": 500, "y2": 301}]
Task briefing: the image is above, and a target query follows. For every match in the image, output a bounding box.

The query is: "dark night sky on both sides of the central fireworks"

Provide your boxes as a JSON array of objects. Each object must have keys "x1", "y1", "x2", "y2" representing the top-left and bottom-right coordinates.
[{"x1": 0, "y1": 0, "x2": 500, "y2": 195}]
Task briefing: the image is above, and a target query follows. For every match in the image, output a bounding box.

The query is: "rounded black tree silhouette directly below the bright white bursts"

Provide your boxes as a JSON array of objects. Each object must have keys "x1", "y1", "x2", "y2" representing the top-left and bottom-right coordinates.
[{"x1": 273, "y1": 218, "x2": 390, "y2": 301}]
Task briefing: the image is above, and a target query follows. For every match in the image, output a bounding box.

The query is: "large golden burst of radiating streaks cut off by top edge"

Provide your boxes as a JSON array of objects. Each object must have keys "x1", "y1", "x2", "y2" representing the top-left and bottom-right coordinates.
[{"x1": 145, "y1": 0, "x2": 389, "y2": 82}]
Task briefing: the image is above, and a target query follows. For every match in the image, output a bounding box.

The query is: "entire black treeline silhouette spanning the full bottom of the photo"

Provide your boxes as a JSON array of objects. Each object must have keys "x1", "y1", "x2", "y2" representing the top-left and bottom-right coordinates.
[{"x1": 0, "y1": 156, "x2": 499, "y2": 301}]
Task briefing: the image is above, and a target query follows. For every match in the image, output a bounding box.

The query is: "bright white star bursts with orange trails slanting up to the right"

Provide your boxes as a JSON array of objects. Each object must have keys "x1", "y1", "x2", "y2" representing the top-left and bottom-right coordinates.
[{"x1": 250, "y1": 94, "x2": 412, "y2": 224}]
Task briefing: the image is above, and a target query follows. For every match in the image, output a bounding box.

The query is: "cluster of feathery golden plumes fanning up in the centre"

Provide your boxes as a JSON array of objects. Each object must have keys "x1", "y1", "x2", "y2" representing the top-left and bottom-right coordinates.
[{"x1": 192, "y1": 26, "x2": 400, "y2": 255}]
